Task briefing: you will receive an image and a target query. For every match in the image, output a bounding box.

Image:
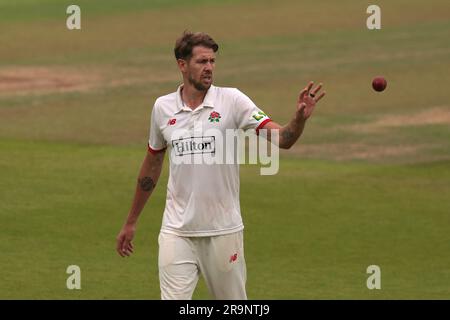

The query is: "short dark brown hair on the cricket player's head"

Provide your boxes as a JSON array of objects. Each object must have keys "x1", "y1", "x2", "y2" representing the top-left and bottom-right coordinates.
[{"x1": 174, "y1": 31, "x2": 219, "y2": 60}]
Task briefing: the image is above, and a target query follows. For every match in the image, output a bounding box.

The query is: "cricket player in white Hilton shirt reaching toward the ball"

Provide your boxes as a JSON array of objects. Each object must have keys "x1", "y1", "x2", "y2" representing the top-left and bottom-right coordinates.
[{"x1": 116, "y1": 32, "x2": 325, "y2": 300}]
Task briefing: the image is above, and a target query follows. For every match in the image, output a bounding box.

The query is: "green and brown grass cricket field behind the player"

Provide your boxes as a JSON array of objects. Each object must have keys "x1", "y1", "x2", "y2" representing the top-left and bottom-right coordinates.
[{"x1": 0, "y1": 0, "x2": 450, "y2": 299}]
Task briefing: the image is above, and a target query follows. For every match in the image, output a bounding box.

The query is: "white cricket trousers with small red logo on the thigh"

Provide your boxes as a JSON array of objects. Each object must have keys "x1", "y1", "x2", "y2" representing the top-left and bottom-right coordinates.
[{"x1": 158, "y1": 231, "x2": 247, "y2": 300}]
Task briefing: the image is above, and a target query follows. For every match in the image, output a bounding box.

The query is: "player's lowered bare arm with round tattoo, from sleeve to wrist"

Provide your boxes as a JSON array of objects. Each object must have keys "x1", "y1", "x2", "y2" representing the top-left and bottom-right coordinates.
[{"x1": 126, "y1": 152, "x2": 164, "y2": 225}]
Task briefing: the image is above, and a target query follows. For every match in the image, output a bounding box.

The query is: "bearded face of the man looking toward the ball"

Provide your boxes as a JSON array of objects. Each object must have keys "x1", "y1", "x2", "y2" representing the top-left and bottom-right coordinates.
[{"x1": 179, "y1": 46, "x2": 216, "y2": 91}]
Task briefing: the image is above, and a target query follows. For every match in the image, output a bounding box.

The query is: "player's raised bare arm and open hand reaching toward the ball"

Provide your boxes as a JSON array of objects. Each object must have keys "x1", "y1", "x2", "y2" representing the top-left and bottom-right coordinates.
[{"x1": 261, "y1": 82, "x2": 325, "y2": 149}]
